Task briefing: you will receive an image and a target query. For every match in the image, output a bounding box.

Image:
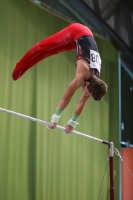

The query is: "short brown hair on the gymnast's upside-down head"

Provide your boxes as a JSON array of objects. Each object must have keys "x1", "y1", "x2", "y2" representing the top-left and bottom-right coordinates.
[{"x1": 87, "y1": 76, "x2": 107, "y2": 101}]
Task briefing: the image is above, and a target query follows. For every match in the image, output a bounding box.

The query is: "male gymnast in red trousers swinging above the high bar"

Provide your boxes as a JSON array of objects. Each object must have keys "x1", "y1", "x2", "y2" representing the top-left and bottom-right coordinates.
[{"x1": 12, "y1": 23, "x2": 107, "y2": 133}]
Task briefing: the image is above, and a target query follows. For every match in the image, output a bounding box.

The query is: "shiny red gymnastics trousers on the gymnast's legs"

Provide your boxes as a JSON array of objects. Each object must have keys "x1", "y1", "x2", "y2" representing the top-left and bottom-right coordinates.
[{"x1": 12, "y1": 23, "x2": 93, "y2": 80}]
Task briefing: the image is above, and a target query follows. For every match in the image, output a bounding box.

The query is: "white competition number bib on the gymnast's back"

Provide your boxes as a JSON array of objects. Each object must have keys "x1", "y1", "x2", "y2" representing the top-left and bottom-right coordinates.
[{"x1": 90, "y1": 50, "x2": 101, "y2": 72}]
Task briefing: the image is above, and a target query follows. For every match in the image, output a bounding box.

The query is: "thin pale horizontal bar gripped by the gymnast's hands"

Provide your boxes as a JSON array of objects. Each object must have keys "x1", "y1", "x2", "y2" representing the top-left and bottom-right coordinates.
[{"x1": 0, "y1": 108, "x2": 110, "y2": 145}]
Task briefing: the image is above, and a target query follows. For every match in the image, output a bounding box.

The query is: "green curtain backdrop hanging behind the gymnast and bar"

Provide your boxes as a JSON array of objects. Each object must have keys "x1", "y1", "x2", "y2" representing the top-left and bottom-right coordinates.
[{"x1": 0, "y1": 0, "x2": 119, "y2": 200}]
